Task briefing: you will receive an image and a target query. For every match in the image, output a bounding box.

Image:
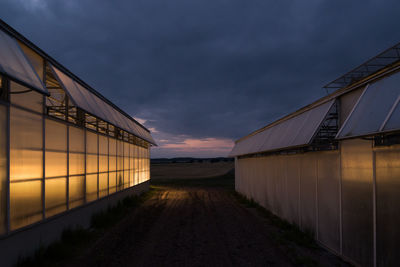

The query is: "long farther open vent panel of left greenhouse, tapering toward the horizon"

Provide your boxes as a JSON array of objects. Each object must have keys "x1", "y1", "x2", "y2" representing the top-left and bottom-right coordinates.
[{"x1": 51, "y1": 66, "x2": 155, "y2": 144}]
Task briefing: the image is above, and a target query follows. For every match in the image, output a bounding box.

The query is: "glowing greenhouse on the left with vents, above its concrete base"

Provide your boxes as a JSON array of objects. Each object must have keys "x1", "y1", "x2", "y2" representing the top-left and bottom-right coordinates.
[{"x1": 0, "y1": 18, "x2": 155, "y2": 262}]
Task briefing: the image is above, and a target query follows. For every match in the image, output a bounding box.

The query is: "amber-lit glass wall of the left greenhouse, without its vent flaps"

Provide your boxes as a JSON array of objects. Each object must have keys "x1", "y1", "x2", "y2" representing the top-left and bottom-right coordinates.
[{"x1": 0, "y1": 32, "x2": 149, "y2": 235}]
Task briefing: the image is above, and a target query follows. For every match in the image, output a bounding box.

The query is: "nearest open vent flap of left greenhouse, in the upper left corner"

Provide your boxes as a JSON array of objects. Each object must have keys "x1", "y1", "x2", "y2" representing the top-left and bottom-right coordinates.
[{"x1": 0, "y1": 30, "x2": 47, "y2": 92}]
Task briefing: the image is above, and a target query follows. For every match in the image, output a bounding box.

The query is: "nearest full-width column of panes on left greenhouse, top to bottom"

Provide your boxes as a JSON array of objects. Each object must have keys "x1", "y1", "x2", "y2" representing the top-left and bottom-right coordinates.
[{"x1": 10, "y1": 82, "x2": 44, "y2": 230}]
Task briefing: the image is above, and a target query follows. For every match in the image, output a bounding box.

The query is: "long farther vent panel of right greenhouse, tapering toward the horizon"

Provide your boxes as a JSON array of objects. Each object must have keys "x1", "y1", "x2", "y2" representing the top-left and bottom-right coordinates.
[{"x1": 230, "y1": 100, "x2": 335, "y2": 157}]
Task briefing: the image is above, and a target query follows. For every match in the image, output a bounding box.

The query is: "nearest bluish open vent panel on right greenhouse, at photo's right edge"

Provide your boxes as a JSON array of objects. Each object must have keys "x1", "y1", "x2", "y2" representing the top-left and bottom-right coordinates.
[{"x1": 336, "y1": 70, "x2": 400, "y2": 139}]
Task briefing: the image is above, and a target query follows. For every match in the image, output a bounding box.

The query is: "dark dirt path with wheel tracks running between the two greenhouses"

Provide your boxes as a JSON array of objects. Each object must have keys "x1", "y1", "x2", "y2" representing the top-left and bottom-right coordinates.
[{"x1": 67, "y1": 187, "x2": 346, "y2": 267}]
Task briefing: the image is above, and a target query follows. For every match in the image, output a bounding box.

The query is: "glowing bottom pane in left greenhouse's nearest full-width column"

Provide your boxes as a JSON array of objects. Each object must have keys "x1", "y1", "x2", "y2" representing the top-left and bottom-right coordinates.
[{"x1": 10, "y1": 181, "x2": 43, "y2": 230}]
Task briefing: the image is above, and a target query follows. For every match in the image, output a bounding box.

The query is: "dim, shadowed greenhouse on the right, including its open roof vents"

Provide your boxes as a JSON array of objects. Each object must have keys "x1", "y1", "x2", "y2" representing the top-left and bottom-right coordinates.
[{"x1": 231, "y1": 44, "x2": 400, "y2": 266}]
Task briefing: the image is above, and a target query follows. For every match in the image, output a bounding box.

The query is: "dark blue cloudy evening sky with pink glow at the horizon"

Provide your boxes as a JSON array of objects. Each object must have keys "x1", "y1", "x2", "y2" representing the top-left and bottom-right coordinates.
[{"x1": 0, "y1": 0, "x2": 400, "y2": 158}]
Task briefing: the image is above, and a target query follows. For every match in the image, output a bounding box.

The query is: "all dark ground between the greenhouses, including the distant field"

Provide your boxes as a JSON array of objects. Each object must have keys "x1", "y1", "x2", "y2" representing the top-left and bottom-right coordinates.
[{"x1": 23, "y1": 162, "x2": 347, "y2": 267}]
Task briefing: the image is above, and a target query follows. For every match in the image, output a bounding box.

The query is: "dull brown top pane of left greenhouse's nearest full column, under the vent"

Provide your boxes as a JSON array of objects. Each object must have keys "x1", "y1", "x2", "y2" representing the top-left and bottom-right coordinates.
[{"x1": 10, "y1": 82, "x2": 43, "y2": 113}]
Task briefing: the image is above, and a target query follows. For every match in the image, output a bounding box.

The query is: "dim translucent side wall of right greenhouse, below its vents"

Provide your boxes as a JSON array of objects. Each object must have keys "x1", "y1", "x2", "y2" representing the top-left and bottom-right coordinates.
[{"x1": 235, "y1": 139, "x2": 400, "y2": 266}]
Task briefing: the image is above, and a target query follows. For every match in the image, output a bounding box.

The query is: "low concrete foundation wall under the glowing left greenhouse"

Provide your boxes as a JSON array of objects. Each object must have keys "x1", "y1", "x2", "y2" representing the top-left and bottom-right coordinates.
[{"x1": 0, "y1": 181, "x2": 150, "y2": 266}]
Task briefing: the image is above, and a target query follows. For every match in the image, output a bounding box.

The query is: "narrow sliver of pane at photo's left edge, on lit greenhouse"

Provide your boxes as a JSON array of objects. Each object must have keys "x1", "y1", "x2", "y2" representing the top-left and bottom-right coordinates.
[{"x1": 0, "y1": 105, "x2": 7, "y2": 234}]
